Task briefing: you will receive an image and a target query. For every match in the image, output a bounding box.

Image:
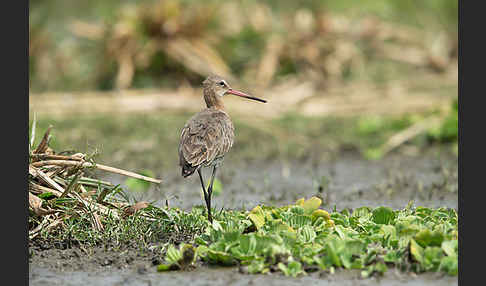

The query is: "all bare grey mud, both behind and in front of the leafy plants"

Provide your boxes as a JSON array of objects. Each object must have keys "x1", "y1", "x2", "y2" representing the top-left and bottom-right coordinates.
[{"x1": 29, "y1": 149, "x2": 458, "y2": 285}]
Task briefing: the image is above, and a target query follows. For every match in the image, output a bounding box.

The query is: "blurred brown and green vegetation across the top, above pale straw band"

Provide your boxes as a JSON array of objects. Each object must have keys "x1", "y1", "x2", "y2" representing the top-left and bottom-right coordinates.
[{"x1": 29, "y1": 0, "x2": 458, "y2": 92}]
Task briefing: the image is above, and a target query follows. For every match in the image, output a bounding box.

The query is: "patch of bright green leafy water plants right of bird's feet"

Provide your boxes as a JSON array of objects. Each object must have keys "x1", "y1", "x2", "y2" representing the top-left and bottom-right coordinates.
[{"x1": 159, "y1": 197, "x2": 458, "y2": 277}]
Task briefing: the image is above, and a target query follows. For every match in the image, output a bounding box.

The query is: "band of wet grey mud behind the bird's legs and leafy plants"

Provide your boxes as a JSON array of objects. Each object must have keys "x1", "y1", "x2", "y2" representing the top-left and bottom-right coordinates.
[{"x1": 136, "y1": 151, "x2": 458, "y2": 210}]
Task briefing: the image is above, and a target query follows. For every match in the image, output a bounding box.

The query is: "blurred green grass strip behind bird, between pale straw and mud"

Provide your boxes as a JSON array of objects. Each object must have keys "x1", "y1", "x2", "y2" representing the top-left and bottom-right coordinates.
[{"x1": 30, "y1": 106, "x2": 458, "y2": 173}]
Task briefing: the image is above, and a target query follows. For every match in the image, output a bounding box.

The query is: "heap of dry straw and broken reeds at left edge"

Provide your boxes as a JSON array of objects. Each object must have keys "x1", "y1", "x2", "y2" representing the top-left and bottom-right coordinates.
[{"x1": 29, "y1": 124, "x2": 162, "y2": 239}]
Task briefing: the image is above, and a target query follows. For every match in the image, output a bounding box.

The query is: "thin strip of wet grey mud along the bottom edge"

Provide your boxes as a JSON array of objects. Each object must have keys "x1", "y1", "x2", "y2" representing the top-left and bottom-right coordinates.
[{"x1": 29, "y1": 267, "x2": 458, "y2": 286}]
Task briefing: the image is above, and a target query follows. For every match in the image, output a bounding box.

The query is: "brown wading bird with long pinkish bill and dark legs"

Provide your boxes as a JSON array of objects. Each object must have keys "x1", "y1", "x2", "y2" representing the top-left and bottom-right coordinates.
[{"x1": 179, "y1": 76, "x2": 266, "y2": 223}]
